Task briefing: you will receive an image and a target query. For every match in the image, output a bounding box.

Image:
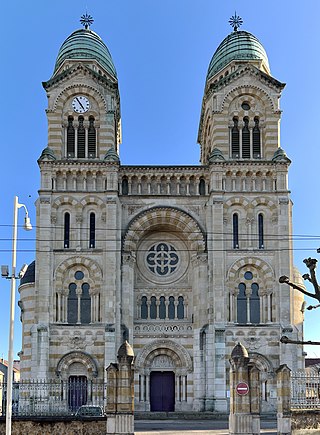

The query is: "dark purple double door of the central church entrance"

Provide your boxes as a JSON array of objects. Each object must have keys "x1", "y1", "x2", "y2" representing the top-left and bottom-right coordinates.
[{"x1": 150, "y1": 371, "x2": 175, "y2": 412}]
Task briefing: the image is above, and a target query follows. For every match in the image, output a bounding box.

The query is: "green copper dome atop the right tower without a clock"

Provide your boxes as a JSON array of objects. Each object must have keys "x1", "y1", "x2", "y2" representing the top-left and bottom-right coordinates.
[{"x1": 207, "y1": 31, "x2": 270, "y2": 80}]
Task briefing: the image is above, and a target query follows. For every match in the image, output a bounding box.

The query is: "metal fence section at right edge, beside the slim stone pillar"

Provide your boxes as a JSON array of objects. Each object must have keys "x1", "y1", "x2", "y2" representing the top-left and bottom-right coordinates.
[{"x1": 291, "y1": 371, "x2": 320, "y2": 409}]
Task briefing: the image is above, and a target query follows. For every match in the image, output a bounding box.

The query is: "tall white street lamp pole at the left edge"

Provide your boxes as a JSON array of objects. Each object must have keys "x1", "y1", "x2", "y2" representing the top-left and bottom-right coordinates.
[{"x1": 1, "y1": 196, "x2": 32, "y2": 435}]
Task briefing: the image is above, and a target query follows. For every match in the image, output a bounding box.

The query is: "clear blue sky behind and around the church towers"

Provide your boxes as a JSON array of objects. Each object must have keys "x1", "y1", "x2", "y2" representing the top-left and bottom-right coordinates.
[{"x1": 0, "y1": 0, "x2": 320, "y2": 358}]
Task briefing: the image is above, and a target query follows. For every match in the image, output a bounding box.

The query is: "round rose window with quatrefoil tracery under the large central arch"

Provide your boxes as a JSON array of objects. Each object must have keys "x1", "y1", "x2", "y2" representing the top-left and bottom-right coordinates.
[{"x1": 146, "y1": 242, "x2": 179, "y2": 276}]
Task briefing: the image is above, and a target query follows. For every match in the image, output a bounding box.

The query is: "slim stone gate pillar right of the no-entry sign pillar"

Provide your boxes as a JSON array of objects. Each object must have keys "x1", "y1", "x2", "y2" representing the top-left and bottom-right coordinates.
[{"x1": 276, "y1": 364, "x2": 291, "y2": 435}]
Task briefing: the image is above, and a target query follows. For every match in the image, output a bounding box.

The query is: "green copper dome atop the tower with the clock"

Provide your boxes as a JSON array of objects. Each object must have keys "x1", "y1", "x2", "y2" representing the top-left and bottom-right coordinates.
[{"x1": 54, "y1": 29, "x2": 117, "y2": 78}]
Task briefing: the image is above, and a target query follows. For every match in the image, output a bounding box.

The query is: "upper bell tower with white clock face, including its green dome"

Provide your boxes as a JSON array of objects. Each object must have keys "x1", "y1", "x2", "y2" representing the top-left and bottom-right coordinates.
[{"x1": 43, "y1": 15, "x2": 121, "y2": 162}]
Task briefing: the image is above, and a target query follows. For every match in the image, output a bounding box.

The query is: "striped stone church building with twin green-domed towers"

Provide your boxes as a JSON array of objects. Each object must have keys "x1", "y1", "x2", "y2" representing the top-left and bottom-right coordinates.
[{"x1": 19, "y1": 17, "x2": 303, "y2": 412}]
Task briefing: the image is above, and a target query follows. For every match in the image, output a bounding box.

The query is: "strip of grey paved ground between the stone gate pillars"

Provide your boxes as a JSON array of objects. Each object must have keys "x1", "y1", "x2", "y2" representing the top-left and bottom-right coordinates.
[{"x1": 134, "y1": 420, "x2": 277, "y2": 435}]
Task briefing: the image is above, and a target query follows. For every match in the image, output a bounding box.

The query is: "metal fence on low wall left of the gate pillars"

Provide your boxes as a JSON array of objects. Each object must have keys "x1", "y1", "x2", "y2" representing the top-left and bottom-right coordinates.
[{"x1": 0, "y1": 377, "x2": 107, "y2": 417}]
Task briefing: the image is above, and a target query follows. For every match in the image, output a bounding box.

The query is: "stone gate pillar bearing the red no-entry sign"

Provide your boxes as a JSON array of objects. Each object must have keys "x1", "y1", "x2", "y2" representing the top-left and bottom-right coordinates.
[{"x1": 229, "y1": 343, "x2": 260, "y2": 435}]
